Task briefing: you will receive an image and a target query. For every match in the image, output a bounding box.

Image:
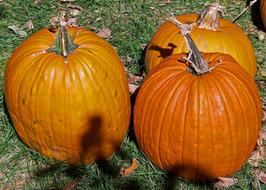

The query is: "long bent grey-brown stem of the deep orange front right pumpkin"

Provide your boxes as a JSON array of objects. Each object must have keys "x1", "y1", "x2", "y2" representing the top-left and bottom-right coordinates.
[{"x1": 169, "y1": 16, "x2": 214, "y2": 76}]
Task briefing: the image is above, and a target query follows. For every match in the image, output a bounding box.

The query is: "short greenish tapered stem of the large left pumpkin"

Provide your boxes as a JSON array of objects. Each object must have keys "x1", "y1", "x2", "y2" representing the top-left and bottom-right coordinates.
[{"x1": 48, "y1": 21, "x2": 78, "y2": 58}]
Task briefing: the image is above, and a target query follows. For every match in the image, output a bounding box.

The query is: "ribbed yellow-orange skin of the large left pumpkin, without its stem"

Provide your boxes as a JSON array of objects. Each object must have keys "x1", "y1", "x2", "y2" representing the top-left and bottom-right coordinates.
[{"x1": 4, "y1": 27, "x2": 130, "y2": 164}]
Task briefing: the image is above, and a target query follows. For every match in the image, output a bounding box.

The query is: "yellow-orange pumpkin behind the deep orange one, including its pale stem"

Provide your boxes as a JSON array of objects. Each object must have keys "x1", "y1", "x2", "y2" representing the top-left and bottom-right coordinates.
[{"x1": 145, "y1": 4, "x2": 256, "y2": 76}]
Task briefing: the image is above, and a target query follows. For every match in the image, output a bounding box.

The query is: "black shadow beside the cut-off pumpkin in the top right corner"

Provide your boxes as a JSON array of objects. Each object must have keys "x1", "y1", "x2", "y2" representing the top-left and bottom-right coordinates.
[{"x1": 246, "y1": 0, "x2": 266, "y2": 32}]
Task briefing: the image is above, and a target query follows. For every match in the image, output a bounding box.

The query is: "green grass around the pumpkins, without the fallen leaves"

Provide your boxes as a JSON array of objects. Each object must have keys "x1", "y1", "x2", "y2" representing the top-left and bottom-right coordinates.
[{"x1": 0, "y1": 0, "x2": 266, "y2": 189}]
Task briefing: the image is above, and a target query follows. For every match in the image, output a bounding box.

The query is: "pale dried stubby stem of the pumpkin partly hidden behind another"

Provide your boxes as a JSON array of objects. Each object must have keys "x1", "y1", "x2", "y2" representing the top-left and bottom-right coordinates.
[{"x1": 197, "y1": 2, "x2": 223, "y2": 31}]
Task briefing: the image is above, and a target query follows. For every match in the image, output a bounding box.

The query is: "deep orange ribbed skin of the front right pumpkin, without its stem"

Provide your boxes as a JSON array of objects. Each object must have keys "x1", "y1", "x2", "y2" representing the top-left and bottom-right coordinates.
[{"x1": 134, "y1": 53, "x2": 262, "y2": 181}]
